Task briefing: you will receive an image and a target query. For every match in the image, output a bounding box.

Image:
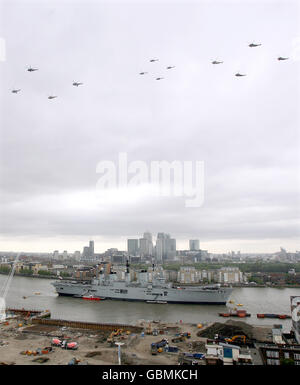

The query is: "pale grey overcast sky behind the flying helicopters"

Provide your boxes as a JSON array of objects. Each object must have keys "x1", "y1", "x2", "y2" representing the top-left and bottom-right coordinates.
[{"x1": 0, "y1": 0, "x2": 300, "y2": 252}]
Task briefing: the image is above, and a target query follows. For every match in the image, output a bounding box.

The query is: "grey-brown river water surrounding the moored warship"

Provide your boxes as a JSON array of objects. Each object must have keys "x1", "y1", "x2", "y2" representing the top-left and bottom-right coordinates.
[{"x1": 0, "y1": 275, "x2": 300, "y2": 332}]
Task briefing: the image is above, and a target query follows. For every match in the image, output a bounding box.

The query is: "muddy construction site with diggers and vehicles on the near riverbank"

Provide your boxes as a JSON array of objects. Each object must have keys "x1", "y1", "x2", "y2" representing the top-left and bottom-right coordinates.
[{"x1": 0, "y1": 309, "x2": 286, "y2": 365}]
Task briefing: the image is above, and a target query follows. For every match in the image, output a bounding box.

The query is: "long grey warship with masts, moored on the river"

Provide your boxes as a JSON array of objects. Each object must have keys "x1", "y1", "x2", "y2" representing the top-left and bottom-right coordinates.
[{"x1": 52, "y1": 263, "x2": 233, "y2": 305}]
